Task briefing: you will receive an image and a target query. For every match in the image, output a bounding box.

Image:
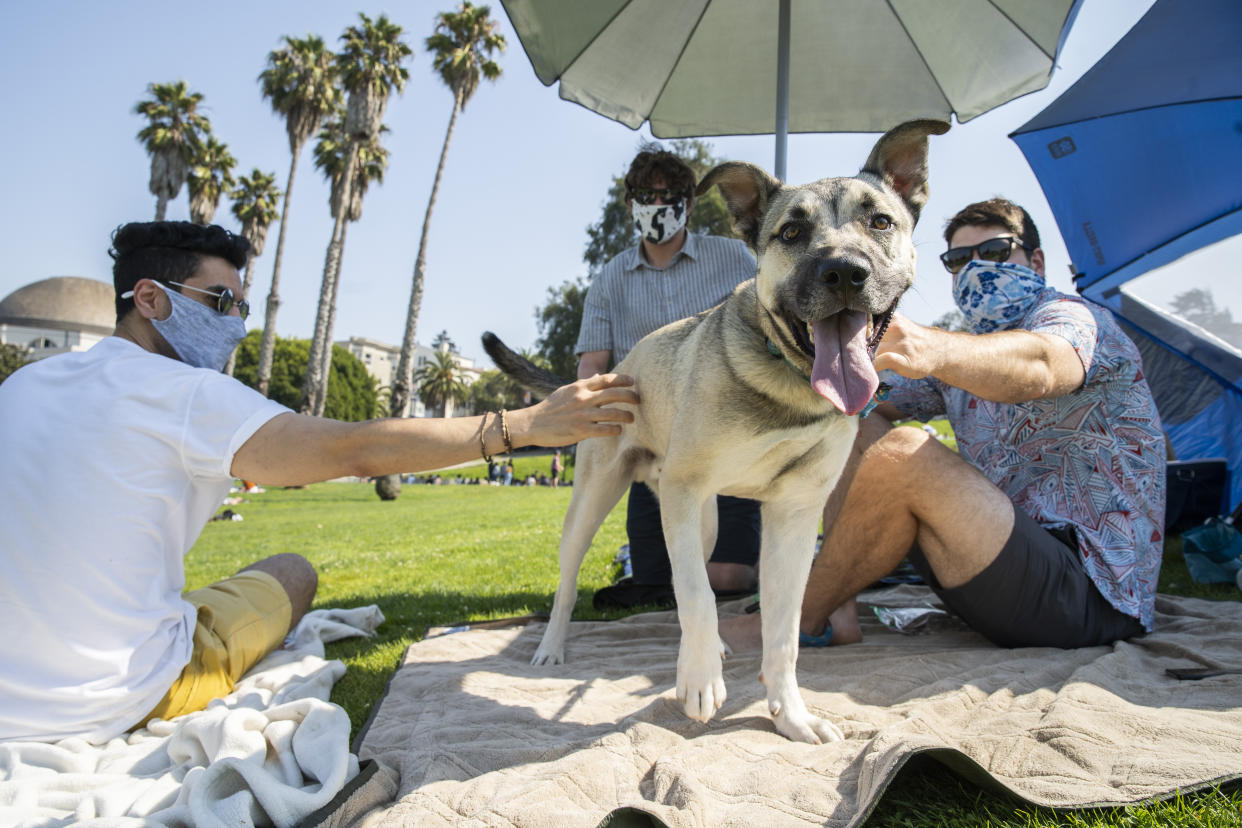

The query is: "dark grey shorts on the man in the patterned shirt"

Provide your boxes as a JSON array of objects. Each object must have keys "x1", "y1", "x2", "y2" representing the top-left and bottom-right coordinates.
[{"x1": 909, "y1": 509, "x2": 1144, "y2": 648}]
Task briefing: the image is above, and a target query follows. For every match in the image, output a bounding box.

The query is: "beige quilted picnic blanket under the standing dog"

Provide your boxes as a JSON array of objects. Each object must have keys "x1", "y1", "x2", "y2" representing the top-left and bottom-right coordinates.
[{"x1": 359, "y1": 586, "x2": 1242, "y2": 828}]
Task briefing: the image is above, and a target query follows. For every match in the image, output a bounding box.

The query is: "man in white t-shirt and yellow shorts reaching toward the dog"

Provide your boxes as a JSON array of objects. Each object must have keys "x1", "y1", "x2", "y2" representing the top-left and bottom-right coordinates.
[{"x1": 0, "y1": 222, "x2": 637, "y2": 742}]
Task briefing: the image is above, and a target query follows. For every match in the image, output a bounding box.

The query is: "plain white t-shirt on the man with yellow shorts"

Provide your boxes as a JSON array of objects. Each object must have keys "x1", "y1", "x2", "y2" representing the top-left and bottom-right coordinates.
[{"x1": 0, "y1": 336, "x2": 288, "y2": 742}]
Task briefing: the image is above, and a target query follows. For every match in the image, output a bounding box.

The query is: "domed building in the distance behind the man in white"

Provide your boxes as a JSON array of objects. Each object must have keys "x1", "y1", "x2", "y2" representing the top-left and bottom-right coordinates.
[{"x1": 0, "y1": 276, "x2": 117, "y2": 359}]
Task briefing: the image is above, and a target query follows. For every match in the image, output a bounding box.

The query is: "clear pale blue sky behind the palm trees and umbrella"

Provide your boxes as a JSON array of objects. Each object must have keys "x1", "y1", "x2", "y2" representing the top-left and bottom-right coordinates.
[{"x1": 9, "y1": 0, "x2": 1212, "y2": 361}]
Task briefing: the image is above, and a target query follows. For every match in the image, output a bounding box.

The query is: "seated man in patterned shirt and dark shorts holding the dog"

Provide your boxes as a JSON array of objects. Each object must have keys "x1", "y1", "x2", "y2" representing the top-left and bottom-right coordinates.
[{"x1": 722, "y1": 199, "x2": 1165, "y2": 649}]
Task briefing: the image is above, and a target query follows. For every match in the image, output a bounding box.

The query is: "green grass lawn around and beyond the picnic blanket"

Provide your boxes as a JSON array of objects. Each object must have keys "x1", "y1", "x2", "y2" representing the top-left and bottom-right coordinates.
[{"x1": 186, "y1": 471, "x2": 1242, "y2": 827}]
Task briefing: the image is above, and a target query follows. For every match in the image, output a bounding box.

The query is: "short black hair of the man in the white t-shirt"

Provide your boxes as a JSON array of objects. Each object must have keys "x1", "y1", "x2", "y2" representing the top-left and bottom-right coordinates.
[{"x1": 108, "y1": 221, "x2": 250, "y2": 322}]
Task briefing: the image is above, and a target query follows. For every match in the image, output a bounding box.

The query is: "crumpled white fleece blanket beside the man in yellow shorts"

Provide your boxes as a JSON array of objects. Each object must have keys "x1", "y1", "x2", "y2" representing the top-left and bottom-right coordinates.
[{"x1": 0, "y1": 606, "x2": 384, "y2": 828}]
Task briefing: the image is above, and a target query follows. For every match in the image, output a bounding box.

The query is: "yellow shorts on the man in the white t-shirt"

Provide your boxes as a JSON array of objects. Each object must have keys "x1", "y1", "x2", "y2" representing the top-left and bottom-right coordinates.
[{"x1": 134, "y1": 570, "x2": 293, "y2": 729}]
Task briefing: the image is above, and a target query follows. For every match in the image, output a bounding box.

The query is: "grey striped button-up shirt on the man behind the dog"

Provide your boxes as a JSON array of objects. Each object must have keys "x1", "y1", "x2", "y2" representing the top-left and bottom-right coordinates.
[{"x1": 574, "y1": 233, "x2": 755, "y2": 364}]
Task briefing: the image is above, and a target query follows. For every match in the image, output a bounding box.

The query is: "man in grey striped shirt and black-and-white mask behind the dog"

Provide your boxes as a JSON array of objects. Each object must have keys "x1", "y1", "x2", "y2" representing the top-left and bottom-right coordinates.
[{"x1": 575, "y1": 150, "x2": 760, "y2": 605}]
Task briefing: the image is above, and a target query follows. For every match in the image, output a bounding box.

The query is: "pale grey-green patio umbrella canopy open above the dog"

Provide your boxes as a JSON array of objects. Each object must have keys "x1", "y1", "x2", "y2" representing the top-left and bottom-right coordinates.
[{"x1": 502, "y1": 0, "x2": 1081, "y2": 179}]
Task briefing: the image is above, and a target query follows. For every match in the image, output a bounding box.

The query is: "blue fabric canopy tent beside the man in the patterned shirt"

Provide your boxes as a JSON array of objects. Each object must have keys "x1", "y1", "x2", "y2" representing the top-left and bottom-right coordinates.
[{"x1": 1010, "y1": 0, "x2": 1242, "y2": 509}]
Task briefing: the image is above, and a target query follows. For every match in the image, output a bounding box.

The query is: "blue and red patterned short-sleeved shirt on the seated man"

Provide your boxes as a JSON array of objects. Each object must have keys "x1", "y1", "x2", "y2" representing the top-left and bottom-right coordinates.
[{"x1": 883, "y1": 288, "x2": 1165, "y2": 631}]
